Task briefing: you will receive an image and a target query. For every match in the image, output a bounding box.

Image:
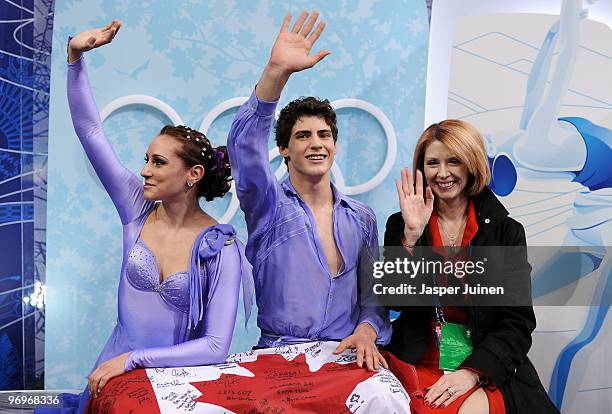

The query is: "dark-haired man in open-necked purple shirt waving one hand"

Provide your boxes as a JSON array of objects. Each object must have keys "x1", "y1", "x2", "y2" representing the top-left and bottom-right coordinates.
[{"x1": 228, "y1": 11, "x2": 391, "y2": 370}]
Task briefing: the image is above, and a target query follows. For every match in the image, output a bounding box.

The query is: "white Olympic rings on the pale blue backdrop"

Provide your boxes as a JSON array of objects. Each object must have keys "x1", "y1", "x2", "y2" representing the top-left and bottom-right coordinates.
[{"x1": 100, "y1": 95, "x2": 397, "y2": 223}]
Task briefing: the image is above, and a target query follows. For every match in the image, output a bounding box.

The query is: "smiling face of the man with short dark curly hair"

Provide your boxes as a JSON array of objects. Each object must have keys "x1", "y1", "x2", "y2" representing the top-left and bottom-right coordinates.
[{"x1": 279, "y1": 116, "x2": 336, "y2": 180}]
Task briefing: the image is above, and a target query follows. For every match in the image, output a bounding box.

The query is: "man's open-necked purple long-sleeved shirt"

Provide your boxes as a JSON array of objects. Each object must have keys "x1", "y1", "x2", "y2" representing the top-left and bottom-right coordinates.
[{"x1": 227, "y1": 92, "x2": 391, "y2": 347}]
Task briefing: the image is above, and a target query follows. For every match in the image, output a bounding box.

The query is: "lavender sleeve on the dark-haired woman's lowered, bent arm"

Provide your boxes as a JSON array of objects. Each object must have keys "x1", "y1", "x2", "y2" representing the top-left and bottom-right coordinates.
[{"x1": 125, "y1": 242, "x2": 245, "y2": 371}]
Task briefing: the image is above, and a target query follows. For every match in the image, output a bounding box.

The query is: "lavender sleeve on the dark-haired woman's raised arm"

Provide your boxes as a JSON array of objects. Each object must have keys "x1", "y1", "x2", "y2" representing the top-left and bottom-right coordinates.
[{"x1": 67, "y1": 56, "x2": 149, "y2": 224}]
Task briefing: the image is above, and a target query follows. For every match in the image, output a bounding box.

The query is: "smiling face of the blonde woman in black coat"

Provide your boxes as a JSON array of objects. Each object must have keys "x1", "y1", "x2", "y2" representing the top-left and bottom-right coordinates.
[{"x1": 423, "y1": 140, "x2": 469, "y2": 201}]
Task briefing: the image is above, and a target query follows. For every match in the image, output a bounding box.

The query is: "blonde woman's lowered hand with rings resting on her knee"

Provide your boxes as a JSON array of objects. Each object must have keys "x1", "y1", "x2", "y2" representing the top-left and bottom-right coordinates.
[{"x1": 425, "y1": 369, "x2": 478, "y2": 408}]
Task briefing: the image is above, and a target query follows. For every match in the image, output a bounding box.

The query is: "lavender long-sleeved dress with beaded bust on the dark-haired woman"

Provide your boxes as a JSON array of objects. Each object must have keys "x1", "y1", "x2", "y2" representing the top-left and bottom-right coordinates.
[{"x1": 68, "y1": 57, "x2": 253, "y2": 382}]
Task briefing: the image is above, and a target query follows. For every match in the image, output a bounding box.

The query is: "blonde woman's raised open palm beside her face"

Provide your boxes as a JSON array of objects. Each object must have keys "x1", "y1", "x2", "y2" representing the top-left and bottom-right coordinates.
[{"x1": 395, "y1": 168, "x2": 434, "y2": 246}]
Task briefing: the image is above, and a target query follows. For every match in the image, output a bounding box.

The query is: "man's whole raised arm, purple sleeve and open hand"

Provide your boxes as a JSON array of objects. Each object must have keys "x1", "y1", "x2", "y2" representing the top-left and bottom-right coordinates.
[{"x1": 227, "y1": 11, "x2": 330, "y2": 234}]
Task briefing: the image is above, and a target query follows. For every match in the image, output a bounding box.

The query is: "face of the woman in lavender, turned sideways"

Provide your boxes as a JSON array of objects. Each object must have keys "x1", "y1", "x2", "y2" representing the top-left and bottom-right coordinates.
[{"x1": 140, "y1": 135, "x2": 193, "y2": 200}]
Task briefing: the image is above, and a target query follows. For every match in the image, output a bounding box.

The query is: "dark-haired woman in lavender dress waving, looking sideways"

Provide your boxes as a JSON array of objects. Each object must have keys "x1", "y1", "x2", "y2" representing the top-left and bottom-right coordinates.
[{"x1": 63, "y1": 20, "x2": 253, "y2": 412}]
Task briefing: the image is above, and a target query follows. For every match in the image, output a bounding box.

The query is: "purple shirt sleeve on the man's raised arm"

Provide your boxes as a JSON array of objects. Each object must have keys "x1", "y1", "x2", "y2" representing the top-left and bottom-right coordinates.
[{"x1": 227, "y1": 91, "x2": 278, "y2": 235}]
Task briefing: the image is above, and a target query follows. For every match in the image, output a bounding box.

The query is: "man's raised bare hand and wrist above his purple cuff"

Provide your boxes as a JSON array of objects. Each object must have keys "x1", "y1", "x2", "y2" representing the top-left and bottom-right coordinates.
[{"x1": 256, "y1": 11, "x2": 331, "y2": 102}]
